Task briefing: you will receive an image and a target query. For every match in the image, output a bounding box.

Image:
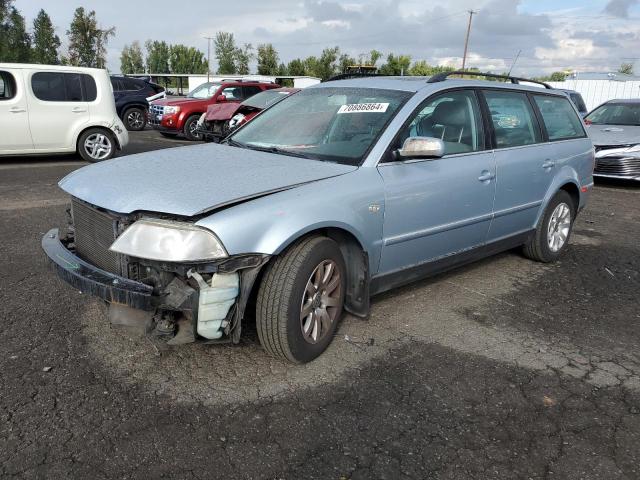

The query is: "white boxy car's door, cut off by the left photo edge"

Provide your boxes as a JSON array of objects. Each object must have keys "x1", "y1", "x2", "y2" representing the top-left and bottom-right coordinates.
[{"x1": 0, "y1": 69, "x2": 33, "y2": 154}]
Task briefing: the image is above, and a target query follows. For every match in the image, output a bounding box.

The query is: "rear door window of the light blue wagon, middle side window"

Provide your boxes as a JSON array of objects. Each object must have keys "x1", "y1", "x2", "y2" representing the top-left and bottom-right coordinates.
[{"x1": 484, "y1": 90, "x2": 542, "y2": 148}]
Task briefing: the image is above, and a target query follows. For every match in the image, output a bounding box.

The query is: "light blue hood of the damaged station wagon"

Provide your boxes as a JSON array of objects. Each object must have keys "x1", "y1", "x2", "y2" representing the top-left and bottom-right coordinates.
[{"x1": 59, "y1": 144, "x2": 357, "y2": 216}]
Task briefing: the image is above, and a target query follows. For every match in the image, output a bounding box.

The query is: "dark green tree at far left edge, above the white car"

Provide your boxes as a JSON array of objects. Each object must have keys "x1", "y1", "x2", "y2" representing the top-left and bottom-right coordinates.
[{"x1": 0, "y1": 5, "x2": 31, "y2": 63}]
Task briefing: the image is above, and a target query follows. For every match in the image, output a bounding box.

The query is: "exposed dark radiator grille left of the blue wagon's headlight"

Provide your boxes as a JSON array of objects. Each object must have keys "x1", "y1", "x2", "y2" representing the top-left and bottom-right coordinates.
[{"x1": 71, "y1": 198, "x2": 121, "y2": 274}]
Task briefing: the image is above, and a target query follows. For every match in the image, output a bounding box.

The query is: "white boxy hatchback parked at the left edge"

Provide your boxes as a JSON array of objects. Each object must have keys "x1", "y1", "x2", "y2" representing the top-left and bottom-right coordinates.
[{"x1": 0, "y1": 63, "x2": 129, "y2": 162}]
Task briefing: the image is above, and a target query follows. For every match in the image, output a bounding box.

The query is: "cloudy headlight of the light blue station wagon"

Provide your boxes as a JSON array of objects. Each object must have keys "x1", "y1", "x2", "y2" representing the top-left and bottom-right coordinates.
[{"x1": 109, "y1": 219, "x2": 227, "y2": 262}]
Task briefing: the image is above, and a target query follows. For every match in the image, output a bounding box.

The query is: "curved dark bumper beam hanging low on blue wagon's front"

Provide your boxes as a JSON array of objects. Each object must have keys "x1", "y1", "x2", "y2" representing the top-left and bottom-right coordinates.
[{"x1": 42, "y1": 228, "x2": 159, "y2": 311}]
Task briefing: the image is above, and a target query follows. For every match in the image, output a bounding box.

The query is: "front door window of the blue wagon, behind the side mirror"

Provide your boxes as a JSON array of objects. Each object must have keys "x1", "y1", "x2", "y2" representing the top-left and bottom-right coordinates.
[{"x1": 397, "y1": 90, "x2": 485, "y2": 155}]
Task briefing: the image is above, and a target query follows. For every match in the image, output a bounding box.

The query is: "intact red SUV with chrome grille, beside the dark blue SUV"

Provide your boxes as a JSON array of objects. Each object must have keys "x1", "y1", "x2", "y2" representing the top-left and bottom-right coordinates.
[{"x1": 148, "y1": 80, "x2": 280, "y2": 140}]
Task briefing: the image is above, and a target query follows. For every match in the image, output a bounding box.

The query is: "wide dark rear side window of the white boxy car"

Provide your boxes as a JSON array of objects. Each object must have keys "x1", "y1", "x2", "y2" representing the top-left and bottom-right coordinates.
[{"x1": 31, "y1": 72, "x2": 97, "y2": 102}]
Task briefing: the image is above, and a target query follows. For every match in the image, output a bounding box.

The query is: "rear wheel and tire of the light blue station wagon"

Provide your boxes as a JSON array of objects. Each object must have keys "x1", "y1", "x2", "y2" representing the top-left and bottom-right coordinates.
[{"x1": 523, "y1": 190, "x2": 576, "y2": 263}]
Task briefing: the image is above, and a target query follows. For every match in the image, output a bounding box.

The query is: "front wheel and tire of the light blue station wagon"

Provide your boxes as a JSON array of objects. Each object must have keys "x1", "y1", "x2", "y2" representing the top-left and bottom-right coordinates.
[{"x1": 256, "y1": 236, "x2": 346, "y2": 363}]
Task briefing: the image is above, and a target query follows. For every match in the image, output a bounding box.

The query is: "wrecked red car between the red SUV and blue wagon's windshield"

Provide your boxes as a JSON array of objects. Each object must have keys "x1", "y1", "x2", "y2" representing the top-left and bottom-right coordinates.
[{"x1": 198, "y1": 88, "x2": 300, "y2": 143}]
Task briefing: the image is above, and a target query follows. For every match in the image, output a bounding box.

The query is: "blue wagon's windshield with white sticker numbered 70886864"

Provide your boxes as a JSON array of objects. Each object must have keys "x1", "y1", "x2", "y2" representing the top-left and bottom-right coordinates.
[{"x1": 229, "y1": 87, "x2": 412, "y2": 165}]
